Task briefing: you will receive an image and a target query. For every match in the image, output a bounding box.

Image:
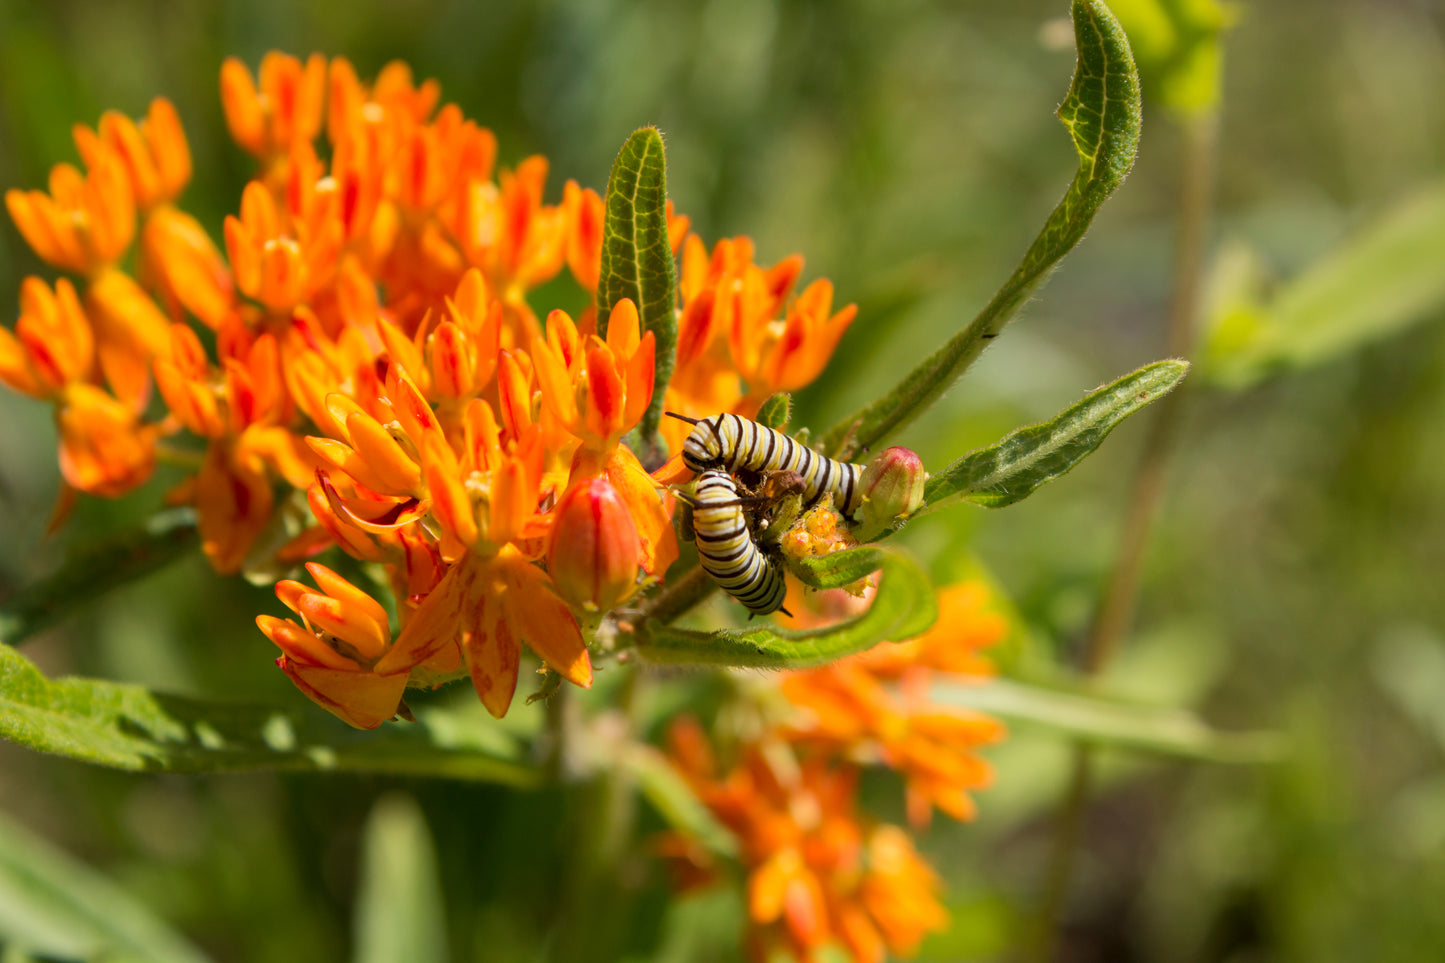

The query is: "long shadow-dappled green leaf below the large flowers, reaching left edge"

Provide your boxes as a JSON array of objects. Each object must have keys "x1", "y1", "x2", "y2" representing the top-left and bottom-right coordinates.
[{"x1": 0, "y1": 645, "x2": 540, "y2": 787}]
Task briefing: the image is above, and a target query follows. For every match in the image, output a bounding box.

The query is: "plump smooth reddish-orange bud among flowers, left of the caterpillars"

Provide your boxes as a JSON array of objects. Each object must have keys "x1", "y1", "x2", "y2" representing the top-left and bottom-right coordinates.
[{"x1": 546, "y1": 477, "x2": 642, "y2": 612}]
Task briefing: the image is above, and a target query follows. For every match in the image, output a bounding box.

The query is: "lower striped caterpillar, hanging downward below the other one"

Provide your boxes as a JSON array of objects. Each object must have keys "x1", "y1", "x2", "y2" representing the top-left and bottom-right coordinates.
[{"x1": 688, "y1": 470, "x2": 788, "y2": 615}]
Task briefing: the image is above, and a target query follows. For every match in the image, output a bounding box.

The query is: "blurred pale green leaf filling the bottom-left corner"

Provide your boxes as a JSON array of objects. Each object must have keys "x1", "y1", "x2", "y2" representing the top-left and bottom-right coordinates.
[{"x1": 0, "y1": 814, "x2": 207, "y2": 963}]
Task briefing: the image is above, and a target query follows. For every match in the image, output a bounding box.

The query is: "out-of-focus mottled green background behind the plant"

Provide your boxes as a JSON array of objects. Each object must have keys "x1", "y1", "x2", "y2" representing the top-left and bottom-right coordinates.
[{"x1": 0, "y1": 0, "x2": 1445, "y2": 963}]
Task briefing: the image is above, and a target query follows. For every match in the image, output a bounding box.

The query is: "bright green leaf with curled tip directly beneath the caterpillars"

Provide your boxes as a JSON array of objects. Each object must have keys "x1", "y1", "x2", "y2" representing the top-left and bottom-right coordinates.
[{"x1": 637, "y1": 545, "x2": 938, "y2": 669}]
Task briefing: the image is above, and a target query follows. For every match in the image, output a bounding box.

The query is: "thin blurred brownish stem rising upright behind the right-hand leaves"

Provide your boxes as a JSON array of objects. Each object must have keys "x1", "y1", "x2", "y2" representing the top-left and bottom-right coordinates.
[{"x1": 1026, "y1": 113, "x2": 1218, "y2": 963}]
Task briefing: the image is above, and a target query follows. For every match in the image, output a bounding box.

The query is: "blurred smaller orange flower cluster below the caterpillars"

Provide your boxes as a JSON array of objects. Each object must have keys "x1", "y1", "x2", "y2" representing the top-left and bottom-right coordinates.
[{"x1": 663, "y1": 572, "x2": 1007, "y2": 963}]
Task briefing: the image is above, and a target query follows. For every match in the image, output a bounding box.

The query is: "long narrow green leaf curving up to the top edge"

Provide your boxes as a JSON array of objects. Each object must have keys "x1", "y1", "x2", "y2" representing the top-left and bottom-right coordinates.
[{"x1": 821, "y1": 0, "x2": 1140, "y2": 460}]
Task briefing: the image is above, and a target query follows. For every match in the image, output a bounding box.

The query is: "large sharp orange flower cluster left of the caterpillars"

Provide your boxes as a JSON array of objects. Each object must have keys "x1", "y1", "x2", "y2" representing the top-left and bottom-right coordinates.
[{"x1": 0, "y1": 54, "x2": 854, "y2": 727}]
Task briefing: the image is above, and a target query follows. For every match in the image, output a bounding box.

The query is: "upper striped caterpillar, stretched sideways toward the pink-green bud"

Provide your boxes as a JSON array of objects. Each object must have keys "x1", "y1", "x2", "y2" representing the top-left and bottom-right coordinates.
[{"x1": 668, "y1": 411, "x2": 863, "y2": 518}]
